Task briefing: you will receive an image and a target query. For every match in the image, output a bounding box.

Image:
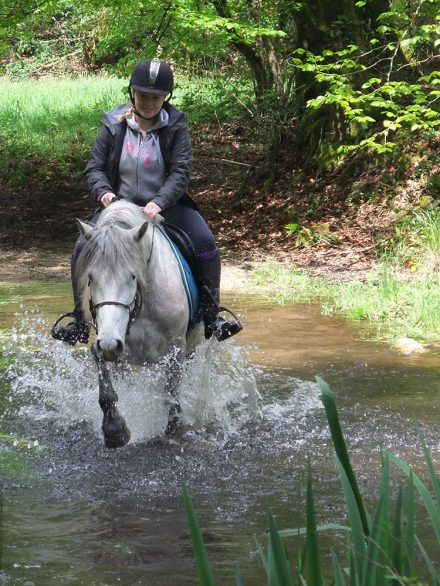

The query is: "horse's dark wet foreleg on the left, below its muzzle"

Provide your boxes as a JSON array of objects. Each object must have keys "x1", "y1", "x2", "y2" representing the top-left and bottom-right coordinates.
[{"x1": 91, "y1": 344, "x2": 130, "y2": 448}]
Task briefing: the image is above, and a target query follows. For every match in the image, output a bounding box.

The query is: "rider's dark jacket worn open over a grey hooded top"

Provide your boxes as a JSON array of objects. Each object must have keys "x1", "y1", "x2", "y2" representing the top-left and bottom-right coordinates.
[{"x1": 85, "y1": 103, "x2": 196, "y2": 211}]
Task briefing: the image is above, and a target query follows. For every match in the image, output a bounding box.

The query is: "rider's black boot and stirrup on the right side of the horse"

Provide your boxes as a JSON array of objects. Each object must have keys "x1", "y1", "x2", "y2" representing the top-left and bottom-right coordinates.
[{"x1": 197, "y1": 250, "x2": 243, "y2": 342}]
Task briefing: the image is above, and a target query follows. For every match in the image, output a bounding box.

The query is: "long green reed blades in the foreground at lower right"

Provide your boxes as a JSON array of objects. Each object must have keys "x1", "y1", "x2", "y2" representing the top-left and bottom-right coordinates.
[{"x1": 183, "y1": 377, "x2": 440, "y2": 586}]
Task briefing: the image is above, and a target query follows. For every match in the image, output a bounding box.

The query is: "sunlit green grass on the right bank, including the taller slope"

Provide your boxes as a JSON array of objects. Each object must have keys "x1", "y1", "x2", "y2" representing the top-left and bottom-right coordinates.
[{"x1": 252, "y1": 208, "x2": 440, "y2": 341}]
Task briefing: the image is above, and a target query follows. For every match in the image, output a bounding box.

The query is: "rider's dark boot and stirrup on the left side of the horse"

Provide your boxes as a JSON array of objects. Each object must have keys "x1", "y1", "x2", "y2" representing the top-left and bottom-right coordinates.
[{"x1": 51, "y1": 244, "x2": 90, "y2": 346}]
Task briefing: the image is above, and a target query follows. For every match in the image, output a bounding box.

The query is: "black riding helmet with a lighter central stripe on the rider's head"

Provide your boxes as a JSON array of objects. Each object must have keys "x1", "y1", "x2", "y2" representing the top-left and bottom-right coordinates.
[{"x1": 130, "y1": 58, "x2": 174, "y2": 96}]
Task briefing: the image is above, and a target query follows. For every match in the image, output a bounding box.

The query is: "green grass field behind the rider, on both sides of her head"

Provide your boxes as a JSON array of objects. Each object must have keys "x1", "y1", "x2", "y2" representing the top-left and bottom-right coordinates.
[{"x1": 0, "y1": 76, "x2": 251, "y2": 185}]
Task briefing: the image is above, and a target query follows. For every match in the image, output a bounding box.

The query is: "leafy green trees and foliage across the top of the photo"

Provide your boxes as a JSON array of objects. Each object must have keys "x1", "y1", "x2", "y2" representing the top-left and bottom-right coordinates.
[{"x1": 0, "y1": 0, "x2": 440, "y2": 175}]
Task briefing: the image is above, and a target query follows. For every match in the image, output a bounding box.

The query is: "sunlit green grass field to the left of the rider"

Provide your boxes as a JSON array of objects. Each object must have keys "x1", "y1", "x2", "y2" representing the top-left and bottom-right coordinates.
[{"x1": 0, "y1": 78, "x2": 123, "y2": 185}]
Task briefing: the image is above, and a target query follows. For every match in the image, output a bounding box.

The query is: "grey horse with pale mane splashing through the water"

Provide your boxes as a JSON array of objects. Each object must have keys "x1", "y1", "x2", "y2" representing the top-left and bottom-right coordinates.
[{"x1": 75, "y1": 201, "x2": 203, "y2": 448}]
